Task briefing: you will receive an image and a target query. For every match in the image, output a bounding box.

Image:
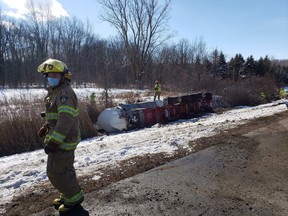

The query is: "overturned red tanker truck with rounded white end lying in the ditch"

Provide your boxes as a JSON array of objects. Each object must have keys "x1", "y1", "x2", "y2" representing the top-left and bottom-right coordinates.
[{"x1": 97, "y1": 93, "x2": 212, "y2": 133}]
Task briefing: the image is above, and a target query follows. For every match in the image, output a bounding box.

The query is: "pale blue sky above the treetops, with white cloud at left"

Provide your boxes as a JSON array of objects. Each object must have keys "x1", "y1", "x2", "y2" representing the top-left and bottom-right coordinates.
[{"x1": 0, "y1": 0, "x2": 288, "y2": 59}]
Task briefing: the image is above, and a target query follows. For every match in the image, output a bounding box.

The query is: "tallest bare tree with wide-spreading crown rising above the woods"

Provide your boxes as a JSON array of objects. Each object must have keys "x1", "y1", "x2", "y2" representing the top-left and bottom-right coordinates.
[{"x1": 98, "y1": 0, "x2": 172, "y2": 87}]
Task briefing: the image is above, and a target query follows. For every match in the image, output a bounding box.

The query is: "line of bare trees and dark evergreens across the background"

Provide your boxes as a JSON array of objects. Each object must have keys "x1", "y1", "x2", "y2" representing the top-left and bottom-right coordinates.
[{"x1": 0, "y1": 0, "x2": 288, "y2": 97}]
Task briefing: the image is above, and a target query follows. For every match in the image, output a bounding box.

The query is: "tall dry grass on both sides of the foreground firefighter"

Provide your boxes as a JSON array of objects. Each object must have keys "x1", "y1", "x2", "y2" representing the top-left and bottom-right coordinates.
[{"x1": 0, "y1": 99, "x2": 98, "y2": 157}]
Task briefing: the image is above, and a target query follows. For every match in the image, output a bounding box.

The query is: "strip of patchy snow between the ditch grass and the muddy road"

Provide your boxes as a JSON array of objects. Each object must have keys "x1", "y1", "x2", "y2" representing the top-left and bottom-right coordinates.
[{"x1": 0, "y1": 87, "x2": 287, "y2": 213}]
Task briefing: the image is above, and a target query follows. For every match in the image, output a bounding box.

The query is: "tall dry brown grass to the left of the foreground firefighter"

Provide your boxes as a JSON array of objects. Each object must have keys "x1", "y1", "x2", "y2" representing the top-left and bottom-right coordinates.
[{"x1": 0, "y1": 99, "x2": 43, "y2": 156}]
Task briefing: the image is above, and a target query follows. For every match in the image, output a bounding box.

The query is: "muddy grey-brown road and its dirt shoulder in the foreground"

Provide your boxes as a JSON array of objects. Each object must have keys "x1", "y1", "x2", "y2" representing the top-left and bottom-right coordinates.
[{"x1": 5, "y1": 112, "x2": 288, "y2": 216}]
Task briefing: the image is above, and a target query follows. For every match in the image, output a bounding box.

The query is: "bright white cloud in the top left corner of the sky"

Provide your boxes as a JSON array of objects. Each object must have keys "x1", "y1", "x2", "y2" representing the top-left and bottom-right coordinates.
[{"x1": 0, "y1": 0, "x2": 69, "y2": 18}]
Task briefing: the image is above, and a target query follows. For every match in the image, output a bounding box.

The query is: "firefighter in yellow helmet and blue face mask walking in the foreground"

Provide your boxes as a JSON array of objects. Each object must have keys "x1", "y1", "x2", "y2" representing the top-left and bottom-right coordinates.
[{"x1": 38, "y1": 59, "x2": 84, "y2": 213}]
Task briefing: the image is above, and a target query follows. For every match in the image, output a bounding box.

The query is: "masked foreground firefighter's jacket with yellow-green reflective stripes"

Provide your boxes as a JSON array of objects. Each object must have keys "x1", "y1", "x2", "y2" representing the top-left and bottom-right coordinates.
[{"x1": 44, "y1": 81, "x2": 81, "y2": 150}]
